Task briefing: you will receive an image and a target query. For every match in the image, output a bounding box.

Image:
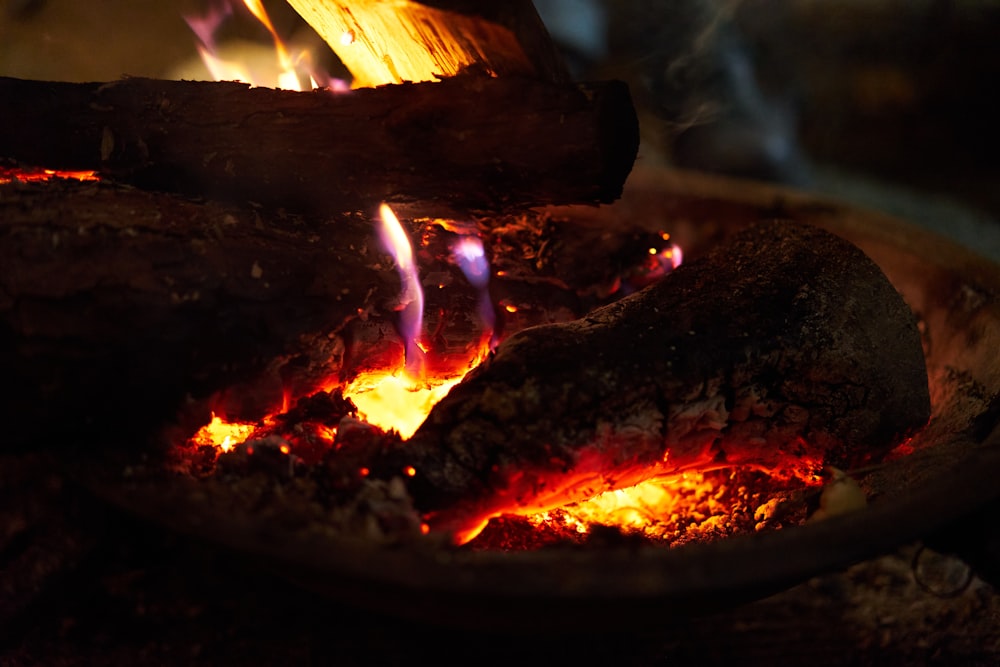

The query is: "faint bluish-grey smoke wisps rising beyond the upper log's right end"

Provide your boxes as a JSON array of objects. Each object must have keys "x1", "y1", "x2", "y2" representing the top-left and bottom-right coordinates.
[{"x1": 604, "y1": 0, "x2": 808, "y2": 184}]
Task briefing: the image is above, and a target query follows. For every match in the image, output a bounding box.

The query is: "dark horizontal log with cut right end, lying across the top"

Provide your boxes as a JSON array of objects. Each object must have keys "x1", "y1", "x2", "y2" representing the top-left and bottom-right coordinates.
[{"x1": 0, "y1": 75, "x2": 638, "y2": 212}]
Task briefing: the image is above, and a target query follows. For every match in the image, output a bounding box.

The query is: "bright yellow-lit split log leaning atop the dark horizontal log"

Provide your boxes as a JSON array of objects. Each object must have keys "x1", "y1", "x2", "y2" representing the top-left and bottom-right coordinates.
[{"x1": 289, "y1": 0, "x2": 569, "y2": 86}]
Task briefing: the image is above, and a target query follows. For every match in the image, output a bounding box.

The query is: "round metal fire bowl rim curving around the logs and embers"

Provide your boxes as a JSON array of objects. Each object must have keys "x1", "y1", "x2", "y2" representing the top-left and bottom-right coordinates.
[{"x1": 88, "y1": 170, "x2": 1000, "y2": 632}]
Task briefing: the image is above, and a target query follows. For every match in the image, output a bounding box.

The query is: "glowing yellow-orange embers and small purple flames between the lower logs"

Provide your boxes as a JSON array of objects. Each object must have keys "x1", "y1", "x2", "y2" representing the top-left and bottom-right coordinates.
[{"x1": 176, "y1": 194, "x2": 796, "y2": 548}]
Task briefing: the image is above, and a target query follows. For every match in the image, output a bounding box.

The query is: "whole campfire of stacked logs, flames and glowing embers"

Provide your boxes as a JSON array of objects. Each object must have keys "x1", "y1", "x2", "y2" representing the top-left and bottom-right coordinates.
[{"x1": 0, "y1": 0, "x2": 1000, "y2": 632}]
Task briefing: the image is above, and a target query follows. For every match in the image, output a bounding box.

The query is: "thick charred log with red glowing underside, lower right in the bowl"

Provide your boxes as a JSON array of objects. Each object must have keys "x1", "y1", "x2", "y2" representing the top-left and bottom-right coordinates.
[{"x1": 356, "y1": 222, "x2": 930, "y2": 540}]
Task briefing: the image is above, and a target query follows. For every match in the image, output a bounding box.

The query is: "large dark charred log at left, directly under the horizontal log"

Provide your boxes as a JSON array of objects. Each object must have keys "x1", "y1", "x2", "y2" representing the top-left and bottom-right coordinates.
[{"x1": 0, "y1": 177, "x2": 659, "y2": 445}]
